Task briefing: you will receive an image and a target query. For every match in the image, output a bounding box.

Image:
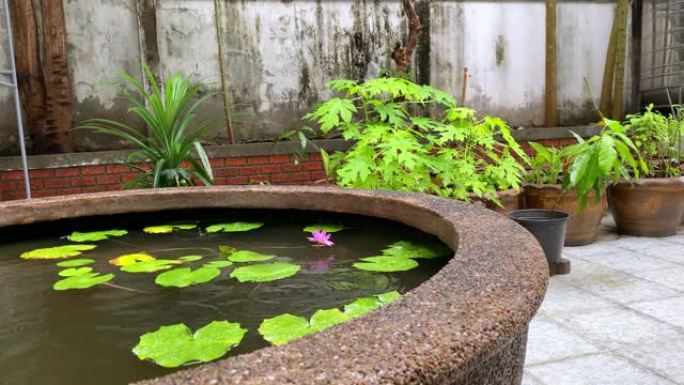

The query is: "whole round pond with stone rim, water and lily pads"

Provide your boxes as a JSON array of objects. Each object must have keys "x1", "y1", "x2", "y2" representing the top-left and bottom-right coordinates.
[{"x1": 0, "y1": 187, "x2": 547, "y2": 384}]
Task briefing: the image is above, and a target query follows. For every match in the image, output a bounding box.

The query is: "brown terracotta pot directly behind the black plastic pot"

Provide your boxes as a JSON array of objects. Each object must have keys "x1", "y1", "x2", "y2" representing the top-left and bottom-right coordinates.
[{"x1": 525, "y1": 185, "x2": 606, "y2": 246}]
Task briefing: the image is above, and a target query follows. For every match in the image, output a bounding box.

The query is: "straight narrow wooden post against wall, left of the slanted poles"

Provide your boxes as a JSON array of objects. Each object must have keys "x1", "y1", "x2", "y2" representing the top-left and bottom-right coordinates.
[{"x1": 544, "y1": 0, "x2": 558, "y2": 127}]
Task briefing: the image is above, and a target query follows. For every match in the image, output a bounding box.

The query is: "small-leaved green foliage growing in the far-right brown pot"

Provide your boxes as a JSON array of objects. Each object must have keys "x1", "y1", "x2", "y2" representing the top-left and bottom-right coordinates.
[{"x1": 625, "y1": 104, "x2": 684, "y2": 178}]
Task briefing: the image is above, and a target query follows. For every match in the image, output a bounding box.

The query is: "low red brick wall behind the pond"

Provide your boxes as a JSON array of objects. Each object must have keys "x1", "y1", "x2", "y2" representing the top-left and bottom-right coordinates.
[{"x1": 0, "y1": 154, "x2": 325, "y2": 201}]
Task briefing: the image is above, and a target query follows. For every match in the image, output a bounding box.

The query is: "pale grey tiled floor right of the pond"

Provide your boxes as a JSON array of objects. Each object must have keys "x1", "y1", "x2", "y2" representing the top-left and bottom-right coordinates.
[{"x1": 523, "y1": 218, "x2": 684, "y2": 385}]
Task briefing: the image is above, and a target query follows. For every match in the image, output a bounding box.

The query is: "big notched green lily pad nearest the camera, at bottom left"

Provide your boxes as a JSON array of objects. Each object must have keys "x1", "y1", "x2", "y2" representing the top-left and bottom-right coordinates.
[{"x1": 133, "y1": 321, "x2": 247, "y2": 368}]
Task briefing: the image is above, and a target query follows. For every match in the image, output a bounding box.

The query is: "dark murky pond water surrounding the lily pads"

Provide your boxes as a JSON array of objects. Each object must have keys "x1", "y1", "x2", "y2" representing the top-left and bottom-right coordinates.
[{"x1": 0, "y1": 210, "x2": 448, "y2": 385}]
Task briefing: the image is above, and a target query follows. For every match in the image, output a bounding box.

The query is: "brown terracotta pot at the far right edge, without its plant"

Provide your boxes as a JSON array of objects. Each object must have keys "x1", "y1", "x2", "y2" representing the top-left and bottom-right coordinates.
[{"x1": 608, "y1": 177, "x2": 684, "y2": 237}]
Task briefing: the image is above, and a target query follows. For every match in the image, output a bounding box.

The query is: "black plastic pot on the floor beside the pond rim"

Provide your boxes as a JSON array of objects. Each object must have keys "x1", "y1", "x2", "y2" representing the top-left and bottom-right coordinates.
[{"x1": 508, "y1": 209, "x2": 570, "y2": 275}]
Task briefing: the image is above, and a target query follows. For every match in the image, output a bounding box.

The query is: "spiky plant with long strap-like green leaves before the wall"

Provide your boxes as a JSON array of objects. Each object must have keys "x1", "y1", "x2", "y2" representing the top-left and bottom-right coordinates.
[{"x1": 77, "y1": 65, "x2": 214, "y2": 188}]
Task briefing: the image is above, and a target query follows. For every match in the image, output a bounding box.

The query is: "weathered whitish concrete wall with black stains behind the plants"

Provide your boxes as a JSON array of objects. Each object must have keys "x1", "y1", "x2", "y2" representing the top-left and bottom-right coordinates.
[{"x1": 0, "y1": 0, "x2": 628, "y2": 152}]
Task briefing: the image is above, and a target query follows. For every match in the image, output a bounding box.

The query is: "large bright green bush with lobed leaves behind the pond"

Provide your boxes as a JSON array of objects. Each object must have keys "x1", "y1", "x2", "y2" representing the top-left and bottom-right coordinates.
[{"x1": 300, "y1": 78, "x2": 527, "y2": 200}]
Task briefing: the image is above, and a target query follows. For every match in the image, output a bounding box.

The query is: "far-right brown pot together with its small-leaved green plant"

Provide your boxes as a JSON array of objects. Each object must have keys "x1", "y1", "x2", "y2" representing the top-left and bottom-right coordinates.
[{"x1": 608, "y1": 105, "x2": 684, "y2": 237}]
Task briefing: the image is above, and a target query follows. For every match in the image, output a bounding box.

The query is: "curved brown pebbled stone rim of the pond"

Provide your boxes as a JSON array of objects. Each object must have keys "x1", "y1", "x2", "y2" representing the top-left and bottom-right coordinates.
[{"x1": 0, "y1": 186, "x2": 548, "y2": 385}]
